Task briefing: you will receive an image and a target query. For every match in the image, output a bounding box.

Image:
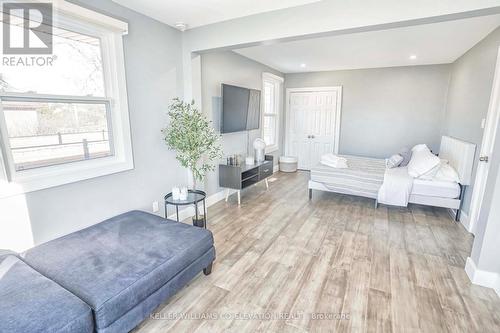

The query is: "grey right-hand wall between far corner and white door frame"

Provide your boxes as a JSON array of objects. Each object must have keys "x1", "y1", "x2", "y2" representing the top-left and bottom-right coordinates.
[{"x1": 443, "y1": 28, "x2": 500, "y2": 213}]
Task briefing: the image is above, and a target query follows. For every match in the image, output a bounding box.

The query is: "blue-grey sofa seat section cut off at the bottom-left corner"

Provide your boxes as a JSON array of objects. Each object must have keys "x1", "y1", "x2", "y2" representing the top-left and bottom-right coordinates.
[{"x1": 0, "y1": 250, "x2": 94, "y2": 333}]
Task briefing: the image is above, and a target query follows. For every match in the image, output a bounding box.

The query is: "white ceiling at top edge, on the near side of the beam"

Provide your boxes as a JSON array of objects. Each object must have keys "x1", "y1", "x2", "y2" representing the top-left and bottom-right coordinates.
[{"x1": 113, "y1": 0, "x2": 320, "y2": 29}]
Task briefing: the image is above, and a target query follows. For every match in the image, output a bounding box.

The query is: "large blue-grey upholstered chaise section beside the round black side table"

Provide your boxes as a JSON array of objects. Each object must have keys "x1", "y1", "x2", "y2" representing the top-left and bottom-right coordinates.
[{"x1": 0, "y1": 211, "x2": 215, "y2": 333}]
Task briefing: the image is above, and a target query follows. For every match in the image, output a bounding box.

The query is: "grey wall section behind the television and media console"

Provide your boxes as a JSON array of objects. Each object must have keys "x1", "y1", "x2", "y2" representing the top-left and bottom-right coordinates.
[{"x1": 201, "y1": 51, "x2": 283, "y2": 194}]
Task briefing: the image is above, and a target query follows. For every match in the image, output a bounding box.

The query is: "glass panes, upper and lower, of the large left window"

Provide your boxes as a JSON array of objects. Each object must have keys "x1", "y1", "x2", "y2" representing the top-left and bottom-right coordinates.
[{"x1": 0, "y1": 22, "x2": 113, "y2": 171}]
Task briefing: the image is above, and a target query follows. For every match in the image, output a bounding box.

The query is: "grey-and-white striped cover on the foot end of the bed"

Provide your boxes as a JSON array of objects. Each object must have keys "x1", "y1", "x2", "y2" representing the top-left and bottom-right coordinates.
[{"x1": 311, "y1": 155, "x2": 385, "y2": 199}]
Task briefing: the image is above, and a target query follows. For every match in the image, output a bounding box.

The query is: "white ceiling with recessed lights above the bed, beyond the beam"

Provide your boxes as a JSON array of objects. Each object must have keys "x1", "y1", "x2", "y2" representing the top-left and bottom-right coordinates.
[{"x1": 235, "y1": 15, "x2": 500, "y2": 73}]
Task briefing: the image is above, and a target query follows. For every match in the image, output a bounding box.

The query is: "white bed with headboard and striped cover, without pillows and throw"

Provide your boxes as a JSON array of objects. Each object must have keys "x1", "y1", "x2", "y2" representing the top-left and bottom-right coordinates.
[{"x1": 309, "y1": 136, "x2": 476, "y2": 219}]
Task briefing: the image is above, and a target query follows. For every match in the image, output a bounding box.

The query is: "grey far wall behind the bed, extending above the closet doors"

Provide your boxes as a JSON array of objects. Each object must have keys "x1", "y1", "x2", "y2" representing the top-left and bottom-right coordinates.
[{"x1": 285, "y1": 65, "x2": 450, "y2": 158}]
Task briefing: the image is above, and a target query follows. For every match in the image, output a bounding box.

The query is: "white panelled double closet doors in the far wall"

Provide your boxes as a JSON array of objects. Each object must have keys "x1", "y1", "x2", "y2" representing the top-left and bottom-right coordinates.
[{"x1": 286, "y1": 87, "x2": 341, "y2": 170}]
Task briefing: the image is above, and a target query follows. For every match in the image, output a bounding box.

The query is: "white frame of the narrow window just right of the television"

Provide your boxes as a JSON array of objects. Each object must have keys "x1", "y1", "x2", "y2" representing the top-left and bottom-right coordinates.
[{"x1": 261, "y1": 72, "x2": 284, "y2": 154}]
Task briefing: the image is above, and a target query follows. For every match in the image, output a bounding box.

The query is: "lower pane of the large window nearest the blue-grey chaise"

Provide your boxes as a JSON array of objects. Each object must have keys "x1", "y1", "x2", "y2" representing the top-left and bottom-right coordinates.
[{"x1": 2, "y1": 99, "x2": 113, "y2": 171}]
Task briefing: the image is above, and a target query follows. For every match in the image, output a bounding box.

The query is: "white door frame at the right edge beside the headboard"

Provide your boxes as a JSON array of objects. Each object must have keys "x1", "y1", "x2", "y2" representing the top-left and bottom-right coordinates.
[{"x1": 467, "y1": 47, "x2": 500, "y2": 234}]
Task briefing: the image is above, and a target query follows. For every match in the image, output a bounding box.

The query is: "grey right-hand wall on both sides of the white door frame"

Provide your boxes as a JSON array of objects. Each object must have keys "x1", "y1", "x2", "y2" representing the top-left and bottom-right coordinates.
[{"x1": 444, "y1": 28, "x2": 500, "y2": 280}]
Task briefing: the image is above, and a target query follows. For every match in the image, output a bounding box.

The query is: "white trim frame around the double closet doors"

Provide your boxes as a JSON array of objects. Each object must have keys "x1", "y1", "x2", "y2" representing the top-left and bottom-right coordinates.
[{"x1": 285, "y1": 86, "x2": 342, "y2": 159}]
